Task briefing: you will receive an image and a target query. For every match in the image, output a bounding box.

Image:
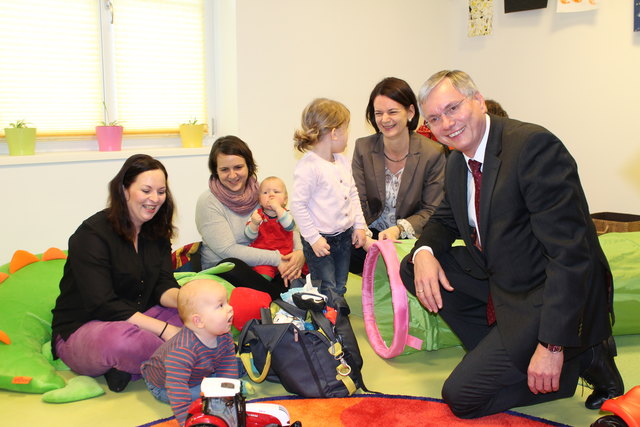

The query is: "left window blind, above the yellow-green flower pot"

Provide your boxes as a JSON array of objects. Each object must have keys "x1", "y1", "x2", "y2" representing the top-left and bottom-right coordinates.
[{"x1": 0, "y1": 0, "x2": 102, "y2": 135}]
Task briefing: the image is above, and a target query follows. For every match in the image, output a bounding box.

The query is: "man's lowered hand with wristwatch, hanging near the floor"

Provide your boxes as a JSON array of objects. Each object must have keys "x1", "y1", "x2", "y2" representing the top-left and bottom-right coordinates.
[{"x1": 527, "y1": 344, "x2": 564, "y2": 394}]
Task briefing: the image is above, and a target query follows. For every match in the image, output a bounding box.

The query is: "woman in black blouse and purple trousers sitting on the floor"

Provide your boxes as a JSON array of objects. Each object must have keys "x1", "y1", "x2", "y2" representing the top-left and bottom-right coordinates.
[{"x1": 52, "y1": 154, "x2": 182, "y2": 392}]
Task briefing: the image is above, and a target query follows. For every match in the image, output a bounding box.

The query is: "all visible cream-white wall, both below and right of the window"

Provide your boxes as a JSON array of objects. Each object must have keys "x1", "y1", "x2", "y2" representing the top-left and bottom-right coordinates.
[{"x1": 0, "y1": 0, "x2": 640, "y2": 264}]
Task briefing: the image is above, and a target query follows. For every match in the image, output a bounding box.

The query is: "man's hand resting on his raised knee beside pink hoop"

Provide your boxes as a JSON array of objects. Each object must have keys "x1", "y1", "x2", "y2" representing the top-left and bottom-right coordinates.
[{"x1": 413, "y1": 250, "x2": 453, "y2": 313}]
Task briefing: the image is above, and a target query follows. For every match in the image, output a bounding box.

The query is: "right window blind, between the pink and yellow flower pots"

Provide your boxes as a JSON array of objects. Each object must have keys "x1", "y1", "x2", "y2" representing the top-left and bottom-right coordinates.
[{"x1": 114, "y1": 0, "x2": 207, "y2": 132}]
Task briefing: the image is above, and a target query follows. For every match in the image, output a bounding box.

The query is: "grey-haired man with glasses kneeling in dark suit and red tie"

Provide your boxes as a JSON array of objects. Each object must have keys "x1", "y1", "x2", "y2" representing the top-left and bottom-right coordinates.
[{"x1": 401, "y1": 71, "x2": 624, "y2": 418}]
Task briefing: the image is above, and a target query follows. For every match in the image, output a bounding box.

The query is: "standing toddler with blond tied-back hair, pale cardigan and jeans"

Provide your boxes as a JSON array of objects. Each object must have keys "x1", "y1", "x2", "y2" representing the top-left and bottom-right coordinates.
[{"x1": 291, "y1": 98, "x2": 367, "y2": 295}]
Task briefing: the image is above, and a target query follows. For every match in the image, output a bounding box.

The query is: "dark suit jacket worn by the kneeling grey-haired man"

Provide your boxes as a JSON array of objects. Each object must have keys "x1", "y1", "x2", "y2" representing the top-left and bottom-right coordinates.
[{"x1": 414, "y1": 115, "x2": 613, "y2": 371}]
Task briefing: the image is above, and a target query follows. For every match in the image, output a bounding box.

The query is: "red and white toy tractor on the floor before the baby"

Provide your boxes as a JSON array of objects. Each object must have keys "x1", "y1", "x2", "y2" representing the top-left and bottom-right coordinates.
[{"x1": 185, "y1": 378, "x2": 302, "y2": 427}]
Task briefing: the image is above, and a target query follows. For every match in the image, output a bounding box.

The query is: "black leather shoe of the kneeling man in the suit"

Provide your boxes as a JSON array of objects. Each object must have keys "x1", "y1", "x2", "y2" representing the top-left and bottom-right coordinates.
[{"x1": 581, "y1": 336, "x2": 624, "y2": 409}]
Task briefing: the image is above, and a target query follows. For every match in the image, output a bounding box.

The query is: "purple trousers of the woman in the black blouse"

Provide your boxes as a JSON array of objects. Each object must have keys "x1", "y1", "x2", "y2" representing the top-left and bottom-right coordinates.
[{"x1": 55, "y1": 305, "x2": 183, "y2": 380}]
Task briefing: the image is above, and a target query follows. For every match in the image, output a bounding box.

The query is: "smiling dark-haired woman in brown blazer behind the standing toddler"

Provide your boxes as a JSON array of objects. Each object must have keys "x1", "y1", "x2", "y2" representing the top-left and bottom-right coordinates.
[{"x1": 350, "y1": 77, "x2": 446, "y2": 274}]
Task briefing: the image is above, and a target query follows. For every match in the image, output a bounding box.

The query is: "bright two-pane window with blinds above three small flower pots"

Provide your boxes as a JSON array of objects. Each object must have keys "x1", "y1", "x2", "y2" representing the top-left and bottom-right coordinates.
[{"x1": 0, "y1": 0, "x2": 208, "y2": 137}]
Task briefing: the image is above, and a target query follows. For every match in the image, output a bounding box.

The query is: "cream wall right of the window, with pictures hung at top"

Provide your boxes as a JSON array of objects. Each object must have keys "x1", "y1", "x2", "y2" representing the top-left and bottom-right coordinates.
[{"x1": 237, "y1": 0, "x2": 640, "y2": 213}]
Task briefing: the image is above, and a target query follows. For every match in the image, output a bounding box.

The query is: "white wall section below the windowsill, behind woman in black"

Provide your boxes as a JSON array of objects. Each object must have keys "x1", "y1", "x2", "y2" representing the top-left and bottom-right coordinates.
[{"x1": 0, "y1": 152, "x2": 209, "y2": 265}]
